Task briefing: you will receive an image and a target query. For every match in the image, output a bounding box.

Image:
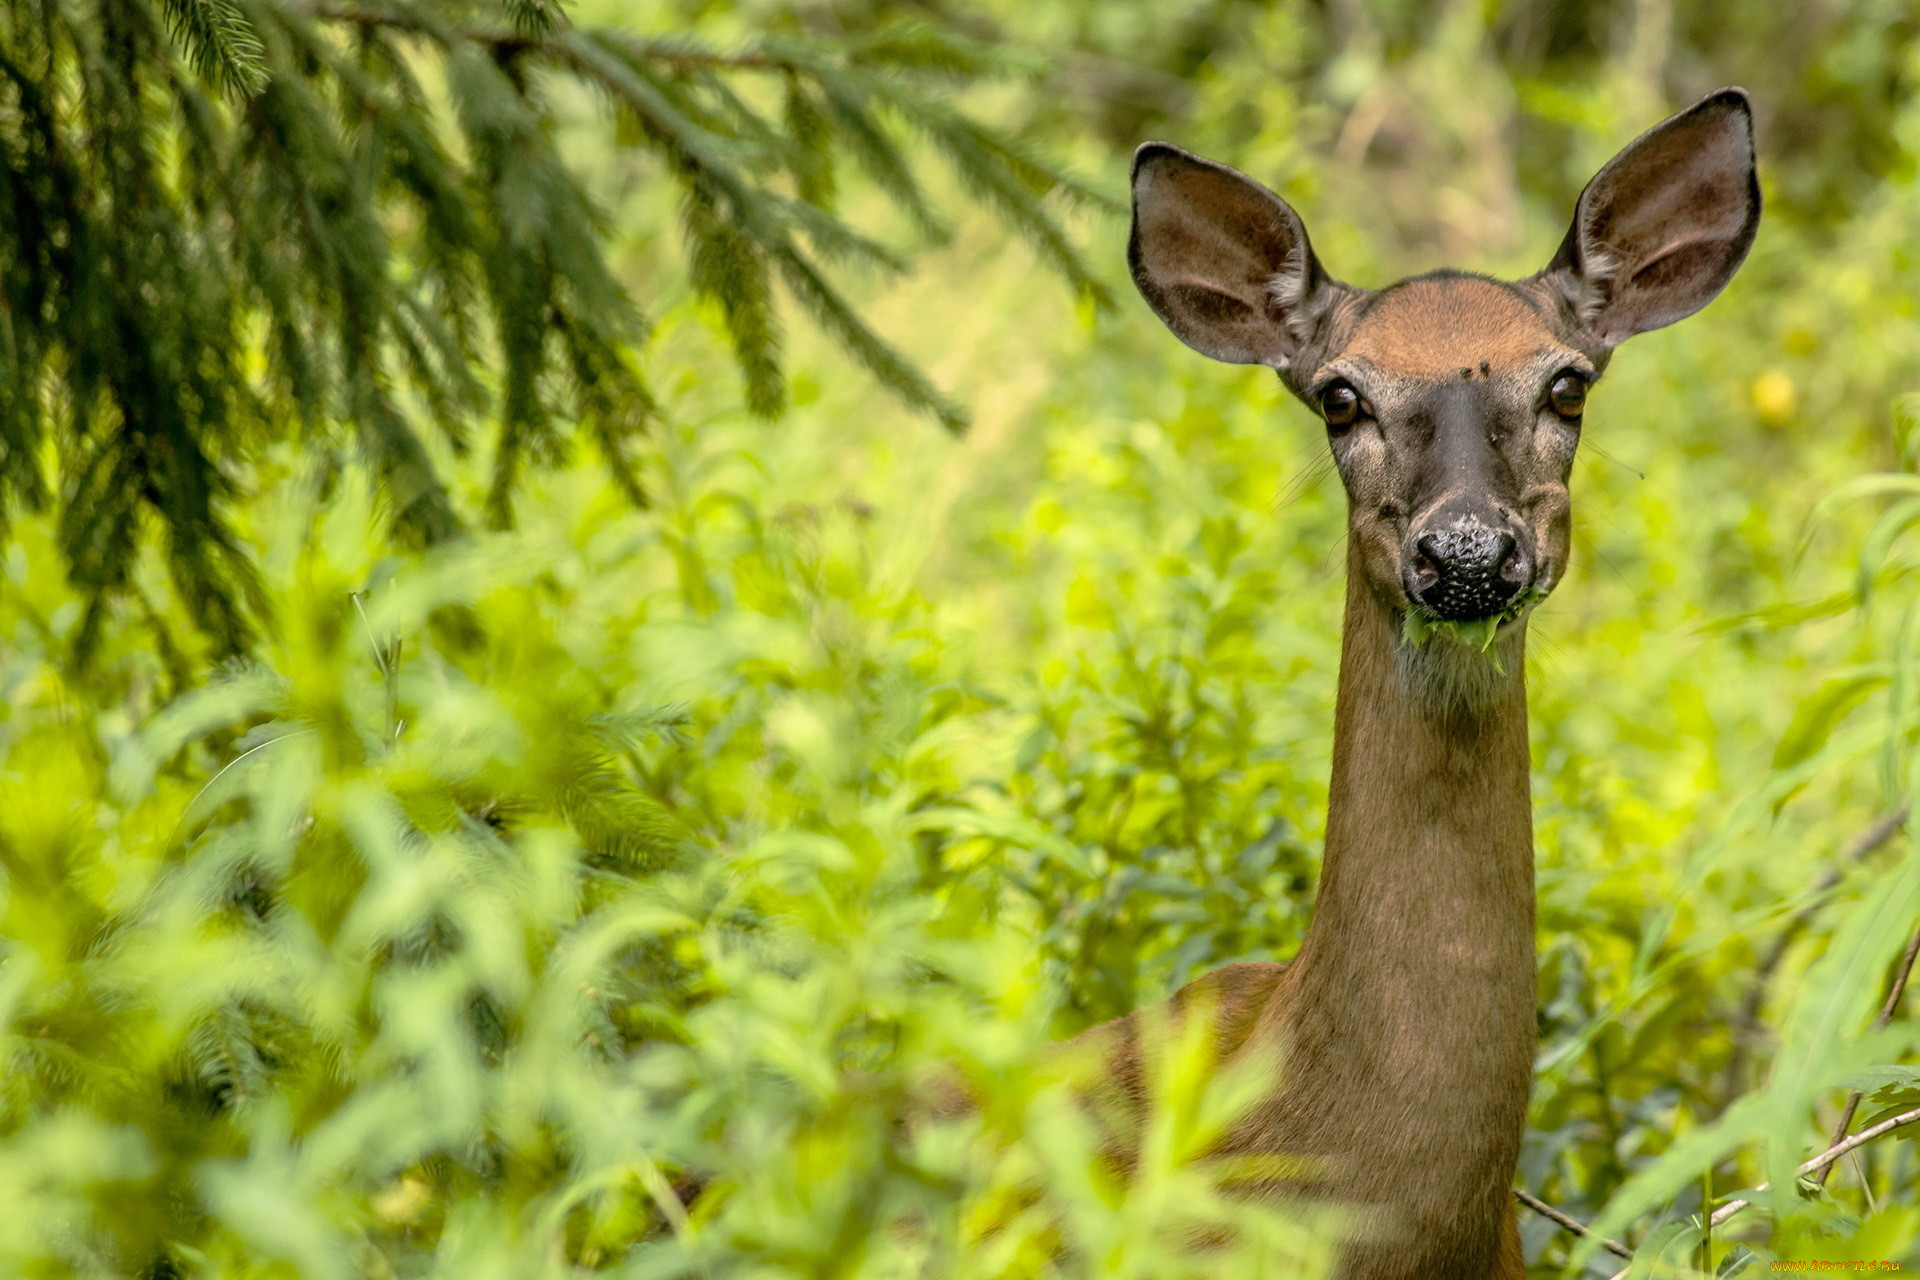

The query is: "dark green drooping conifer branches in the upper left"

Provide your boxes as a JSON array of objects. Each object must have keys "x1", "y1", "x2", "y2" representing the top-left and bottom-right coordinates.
[{"x1": 0, "y1": 0, "x2": 1102, "y2": 651}]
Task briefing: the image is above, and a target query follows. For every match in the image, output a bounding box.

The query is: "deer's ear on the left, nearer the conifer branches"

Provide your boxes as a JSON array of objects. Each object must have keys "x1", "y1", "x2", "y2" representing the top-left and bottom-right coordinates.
[{"x1": 1127, "y1": 142, "x2": 1327, "y2": 368}]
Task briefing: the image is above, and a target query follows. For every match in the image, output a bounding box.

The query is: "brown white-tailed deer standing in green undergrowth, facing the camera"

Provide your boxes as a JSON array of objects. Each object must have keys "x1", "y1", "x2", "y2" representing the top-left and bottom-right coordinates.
[{"x1": 1087, "y1": 88, "x2": 1761, "y2": 1280}]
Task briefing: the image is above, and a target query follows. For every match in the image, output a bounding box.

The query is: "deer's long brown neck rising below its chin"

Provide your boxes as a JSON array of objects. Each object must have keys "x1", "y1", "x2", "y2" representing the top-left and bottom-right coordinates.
[{"x1": 1283, "y1": 545, "x2": 1534, "y2": 1274}]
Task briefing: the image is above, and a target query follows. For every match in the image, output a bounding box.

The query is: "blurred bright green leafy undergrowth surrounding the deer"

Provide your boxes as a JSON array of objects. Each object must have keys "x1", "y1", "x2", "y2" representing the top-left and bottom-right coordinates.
[{"x1": 11, "y1": 0, "x2": 1920, "y2": 1278}]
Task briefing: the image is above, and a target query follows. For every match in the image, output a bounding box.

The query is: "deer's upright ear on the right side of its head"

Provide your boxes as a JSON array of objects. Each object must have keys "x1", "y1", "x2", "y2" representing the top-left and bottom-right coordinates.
[{"x1": 1542, "y1": 88, "x2": 1761, "y2": 347}]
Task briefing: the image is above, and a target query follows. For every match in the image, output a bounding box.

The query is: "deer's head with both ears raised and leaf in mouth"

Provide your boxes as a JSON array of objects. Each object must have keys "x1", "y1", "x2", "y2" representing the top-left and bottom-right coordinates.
[{"x1": 1127, "y1": 88, "x2": 1761, "y2": 704}]
